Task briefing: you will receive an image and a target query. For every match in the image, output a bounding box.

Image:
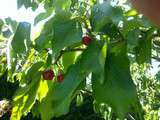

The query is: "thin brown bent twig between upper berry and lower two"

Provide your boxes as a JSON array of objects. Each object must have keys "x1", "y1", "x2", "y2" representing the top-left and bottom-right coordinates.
[{"x1": 54, "y1": 48, "x2": 85, "y2": 64}]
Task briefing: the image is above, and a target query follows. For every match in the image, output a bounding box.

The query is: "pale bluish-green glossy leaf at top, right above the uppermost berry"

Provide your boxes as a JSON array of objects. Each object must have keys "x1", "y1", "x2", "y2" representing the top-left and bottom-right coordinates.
[{"x1": 91, "y1": 2, "x2": 123, "y2": 32}]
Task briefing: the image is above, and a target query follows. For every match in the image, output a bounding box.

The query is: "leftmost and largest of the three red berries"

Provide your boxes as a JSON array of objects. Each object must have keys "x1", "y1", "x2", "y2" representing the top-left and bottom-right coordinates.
[{"x1": 42, "y1": 70, "x2": 54, "y2": 80}]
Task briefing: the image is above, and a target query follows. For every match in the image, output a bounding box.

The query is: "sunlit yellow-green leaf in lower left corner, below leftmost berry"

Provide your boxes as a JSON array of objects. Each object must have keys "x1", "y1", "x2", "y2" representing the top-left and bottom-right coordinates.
[{"x1": 11, "y1": 72, "x2": 41, "y2": 120}]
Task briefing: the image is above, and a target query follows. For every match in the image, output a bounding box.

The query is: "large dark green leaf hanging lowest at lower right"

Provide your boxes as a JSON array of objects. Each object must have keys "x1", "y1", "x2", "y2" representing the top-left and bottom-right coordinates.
[{"x1": 92, "y1": 43, "x2": 137, "y2": 118}]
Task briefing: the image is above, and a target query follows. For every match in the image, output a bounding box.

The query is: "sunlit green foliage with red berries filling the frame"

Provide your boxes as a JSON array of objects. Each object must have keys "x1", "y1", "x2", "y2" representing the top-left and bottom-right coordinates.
[{"x1": 0, "y1": 0, "x2": 160, "y2": 120}]
